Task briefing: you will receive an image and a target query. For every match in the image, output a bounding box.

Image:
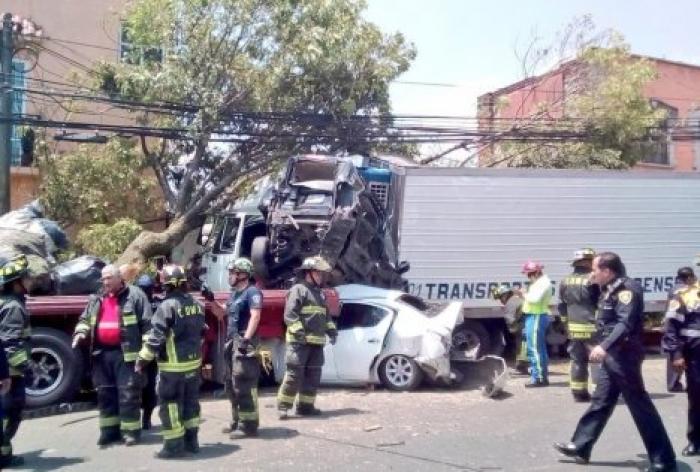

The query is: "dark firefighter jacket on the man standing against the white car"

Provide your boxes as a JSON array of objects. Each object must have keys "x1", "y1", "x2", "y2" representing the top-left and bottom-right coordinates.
[{"x1": 284, "y1": 281, "x2": 338, "y2": 346}]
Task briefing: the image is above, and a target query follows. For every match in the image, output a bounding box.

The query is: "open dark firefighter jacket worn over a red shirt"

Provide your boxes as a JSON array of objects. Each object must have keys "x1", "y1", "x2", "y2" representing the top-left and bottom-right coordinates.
[{"x1": 75, "y1": 285, "x2": 152, "y2": 362}]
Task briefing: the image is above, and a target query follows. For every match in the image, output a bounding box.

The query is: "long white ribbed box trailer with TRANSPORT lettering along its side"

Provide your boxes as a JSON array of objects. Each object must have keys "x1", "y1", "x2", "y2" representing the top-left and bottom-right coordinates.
[{"x1": 395, "y1": 167, "x2": 700, "y2": 353}]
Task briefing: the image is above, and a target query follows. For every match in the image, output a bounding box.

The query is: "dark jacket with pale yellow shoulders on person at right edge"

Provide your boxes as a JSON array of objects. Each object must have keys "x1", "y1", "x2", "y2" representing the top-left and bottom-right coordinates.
[{"x1": 661, "y1": 285, "x2": 700, "y2": 360}]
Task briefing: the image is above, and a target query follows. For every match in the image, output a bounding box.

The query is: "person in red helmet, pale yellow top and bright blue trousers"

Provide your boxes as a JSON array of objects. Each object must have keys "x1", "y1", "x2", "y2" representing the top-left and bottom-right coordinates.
[{"x1": 517, "y1": 261, "x2": 552, "y2": 387}]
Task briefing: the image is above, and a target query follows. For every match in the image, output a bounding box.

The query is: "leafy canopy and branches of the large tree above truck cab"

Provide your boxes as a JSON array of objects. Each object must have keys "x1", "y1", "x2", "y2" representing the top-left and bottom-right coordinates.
[{"x1": 89, "y1": 0, "x2": 415, "y2": 259}]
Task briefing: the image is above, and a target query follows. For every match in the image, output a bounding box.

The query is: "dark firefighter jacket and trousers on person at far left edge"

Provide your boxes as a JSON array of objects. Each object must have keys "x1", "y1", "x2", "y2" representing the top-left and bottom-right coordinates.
[{"x1": 0, "y1": 294, "x2": 30, "y2": 467}]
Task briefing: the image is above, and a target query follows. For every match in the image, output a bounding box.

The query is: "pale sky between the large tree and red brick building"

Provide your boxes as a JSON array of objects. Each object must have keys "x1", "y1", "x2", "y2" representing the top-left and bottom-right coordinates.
[{"x1": 365, "y1": 0, "x2": 700, "y2": 120}]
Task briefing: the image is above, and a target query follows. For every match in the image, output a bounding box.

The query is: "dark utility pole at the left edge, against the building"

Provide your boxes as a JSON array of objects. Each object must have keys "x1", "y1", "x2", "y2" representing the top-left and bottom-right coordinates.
[{"x1": 0, "y1": 13, "x2": 14, "y2": 215}]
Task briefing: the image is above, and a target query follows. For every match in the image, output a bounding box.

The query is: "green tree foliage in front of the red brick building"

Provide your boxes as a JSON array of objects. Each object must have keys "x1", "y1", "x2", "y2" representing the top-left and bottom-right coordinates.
[{"x1": 490, "y1": 21, "x2": 666, "y2": 169}]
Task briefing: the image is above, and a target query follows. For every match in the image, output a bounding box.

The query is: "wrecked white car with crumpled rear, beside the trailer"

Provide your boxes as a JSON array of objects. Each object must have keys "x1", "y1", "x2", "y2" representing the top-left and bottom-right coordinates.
[{"x1": 321, "y1": 285, "x2": 462, "y2": 390}]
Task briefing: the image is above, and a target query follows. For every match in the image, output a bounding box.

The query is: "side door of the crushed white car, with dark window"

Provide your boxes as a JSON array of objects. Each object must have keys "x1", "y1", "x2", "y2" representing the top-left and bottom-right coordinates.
[{"x1": 326, "y1": 302, "x2": 395, "y2": 382}]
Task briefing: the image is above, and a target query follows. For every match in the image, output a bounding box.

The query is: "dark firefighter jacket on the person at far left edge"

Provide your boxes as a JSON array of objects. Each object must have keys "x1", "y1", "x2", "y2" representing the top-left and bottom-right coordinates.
[{"x1": 0, "y1": 294, "x2": 31, "y2": 376}]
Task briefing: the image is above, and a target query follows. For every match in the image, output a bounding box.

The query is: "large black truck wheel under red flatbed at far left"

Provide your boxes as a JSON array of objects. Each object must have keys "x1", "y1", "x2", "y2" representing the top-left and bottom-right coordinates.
[{"x1": 26, "y1": 328, "x2": 83, "y2": 408}]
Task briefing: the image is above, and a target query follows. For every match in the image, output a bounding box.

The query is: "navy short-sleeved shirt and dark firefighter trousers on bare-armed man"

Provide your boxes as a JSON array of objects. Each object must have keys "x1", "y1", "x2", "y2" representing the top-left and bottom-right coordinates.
[{"x1": 225, "y1": 285, "x2": 263, "y2": 435}]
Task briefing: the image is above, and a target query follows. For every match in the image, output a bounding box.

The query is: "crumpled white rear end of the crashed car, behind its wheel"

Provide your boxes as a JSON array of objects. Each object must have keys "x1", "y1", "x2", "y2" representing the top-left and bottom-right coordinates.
[{"x1": 415, "y1": 302, "x2": 463, "y2": 381}]
